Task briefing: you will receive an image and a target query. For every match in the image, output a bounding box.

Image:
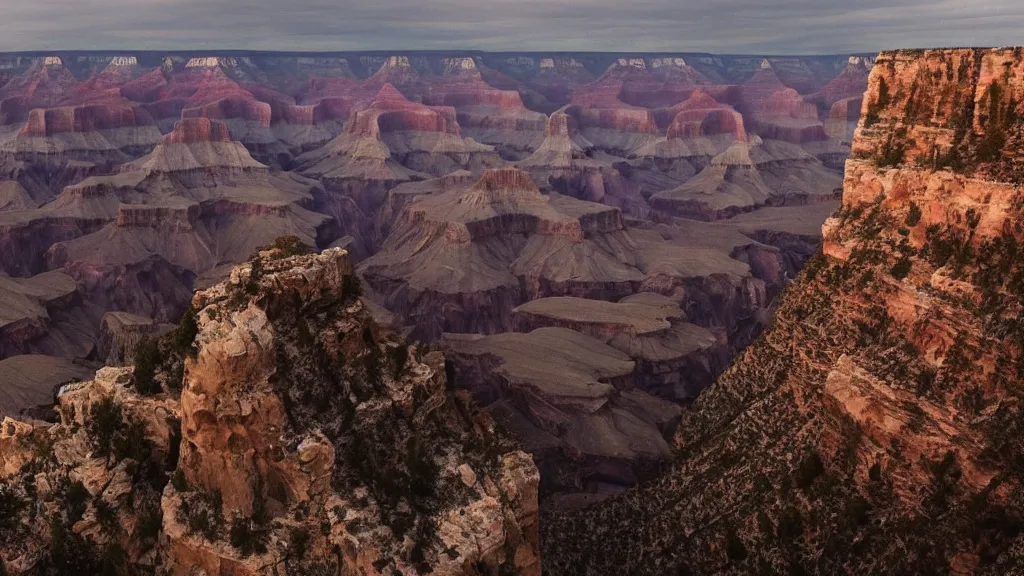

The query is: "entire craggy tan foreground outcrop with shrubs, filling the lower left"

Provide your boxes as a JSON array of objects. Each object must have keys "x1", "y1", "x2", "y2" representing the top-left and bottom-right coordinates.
[{"x1": 0, "y1": 250, "x2": 540, "y2": 575}]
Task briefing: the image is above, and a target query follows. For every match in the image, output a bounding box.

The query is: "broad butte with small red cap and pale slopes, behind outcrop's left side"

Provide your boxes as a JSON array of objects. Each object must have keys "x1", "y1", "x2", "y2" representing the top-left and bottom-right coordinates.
[{"x1": 11, "y1": 119, "x2": 331, "y2": 328}]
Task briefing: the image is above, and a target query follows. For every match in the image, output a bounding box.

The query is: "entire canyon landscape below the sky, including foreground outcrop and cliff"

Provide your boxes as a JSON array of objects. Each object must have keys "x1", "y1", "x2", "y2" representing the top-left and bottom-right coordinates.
[{"x1": 0, "y1": 44, "x2": 1024, "y2": 576}]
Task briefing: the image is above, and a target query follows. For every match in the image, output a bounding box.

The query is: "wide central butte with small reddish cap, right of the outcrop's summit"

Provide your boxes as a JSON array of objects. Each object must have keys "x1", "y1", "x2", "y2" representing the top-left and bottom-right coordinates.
[{"x1": 360, "y1": 169, "x2": 642, "y2": 338}]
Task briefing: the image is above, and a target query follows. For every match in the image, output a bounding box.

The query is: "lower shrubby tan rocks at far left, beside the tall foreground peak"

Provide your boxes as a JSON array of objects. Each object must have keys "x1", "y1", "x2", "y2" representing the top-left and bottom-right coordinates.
[{"x1": 0, "y1": 359, "x2": 178, "y2": 574}]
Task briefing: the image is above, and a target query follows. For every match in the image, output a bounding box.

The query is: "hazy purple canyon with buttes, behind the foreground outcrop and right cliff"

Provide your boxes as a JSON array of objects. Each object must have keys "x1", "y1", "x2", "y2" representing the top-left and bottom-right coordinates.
[{"x1": 0, "y1": 52, "x2": 873, "y2": 504}]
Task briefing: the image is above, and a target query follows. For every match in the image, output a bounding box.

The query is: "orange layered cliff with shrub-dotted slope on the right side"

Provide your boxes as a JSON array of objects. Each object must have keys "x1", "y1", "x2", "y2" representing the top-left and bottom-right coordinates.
[{"x1": 543, "y1": 45, "x2": 1024, "y2": 574}]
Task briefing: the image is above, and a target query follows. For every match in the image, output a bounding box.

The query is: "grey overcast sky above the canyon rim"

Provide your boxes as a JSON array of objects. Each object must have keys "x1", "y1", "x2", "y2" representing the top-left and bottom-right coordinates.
[{"x1": 0, "y1": 0, "x2": 1024, "y2": 54}]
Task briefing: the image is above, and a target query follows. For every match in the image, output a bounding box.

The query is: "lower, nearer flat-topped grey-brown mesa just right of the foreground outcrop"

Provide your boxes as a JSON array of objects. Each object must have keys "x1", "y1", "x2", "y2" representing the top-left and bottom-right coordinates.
[{"x1": 442, "y1": 328, "x2": 680, "y2": 508}]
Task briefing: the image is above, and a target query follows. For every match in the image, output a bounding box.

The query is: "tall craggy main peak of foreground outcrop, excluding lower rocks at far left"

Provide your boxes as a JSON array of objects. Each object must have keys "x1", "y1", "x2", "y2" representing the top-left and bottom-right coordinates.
[{"x1": 163, "y1": 250, "x2": 540, "y2": 574}]
